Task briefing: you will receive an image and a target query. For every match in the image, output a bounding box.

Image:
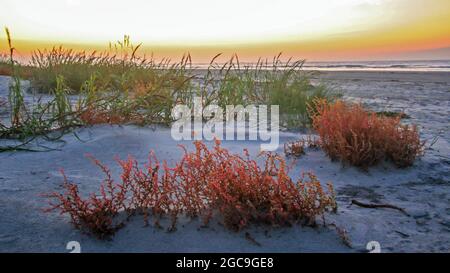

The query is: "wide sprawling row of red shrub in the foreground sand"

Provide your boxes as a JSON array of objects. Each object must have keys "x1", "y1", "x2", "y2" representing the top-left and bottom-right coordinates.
[{"x1": 48, "y1": 141, "x2": 336, "y2": 235}]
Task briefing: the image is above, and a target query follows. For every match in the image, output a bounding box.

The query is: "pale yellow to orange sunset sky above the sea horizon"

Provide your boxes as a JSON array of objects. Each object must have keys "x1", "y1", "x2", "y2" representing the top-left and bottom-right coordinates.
[{"x1": 0, "y1": 0, "x2": 450, "y2": 62}]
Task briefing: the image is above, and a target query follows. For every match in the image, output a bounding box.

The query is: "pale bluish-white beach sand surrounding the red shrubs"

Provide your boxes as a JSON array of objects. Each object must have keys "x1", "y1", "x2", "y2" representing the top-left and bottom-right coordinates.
[{"x1": 0, "y1": 72, "x2": 450, "y2": 252}]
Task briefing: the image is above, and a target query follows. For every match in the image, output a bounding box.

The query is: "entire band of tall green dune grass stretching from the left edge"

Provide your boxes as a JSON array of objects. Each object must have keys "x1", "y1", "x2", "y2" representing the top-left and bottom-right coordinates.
[{"x1": 0, "y1": 29, "x2": 334, "y2": 151}]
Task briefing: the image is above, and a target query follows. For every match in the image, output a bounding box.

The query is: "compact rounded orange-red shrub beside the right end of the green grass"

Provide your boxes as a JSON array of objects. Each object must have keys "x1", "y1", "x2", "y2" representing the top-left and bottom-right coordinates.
[{"x1": 311, "y1": 100, "x2": 424, "y2": 169}]
